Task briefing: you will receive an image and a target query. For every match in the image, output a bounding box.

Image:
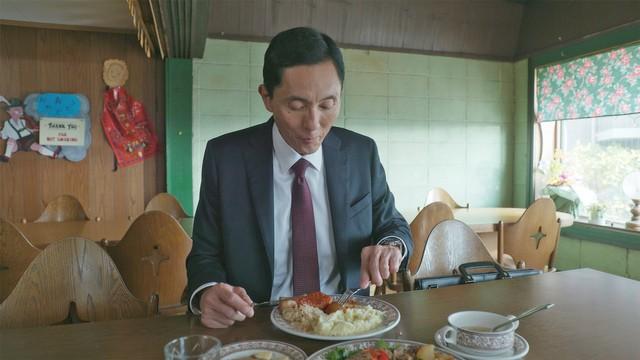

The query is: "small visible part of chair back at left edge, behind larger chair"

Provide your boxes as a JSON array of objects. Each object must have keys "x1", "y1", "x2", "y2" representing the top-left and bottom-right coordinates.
[{"x1": 0, "y1": 218, "x2": 40, "y2": 302}]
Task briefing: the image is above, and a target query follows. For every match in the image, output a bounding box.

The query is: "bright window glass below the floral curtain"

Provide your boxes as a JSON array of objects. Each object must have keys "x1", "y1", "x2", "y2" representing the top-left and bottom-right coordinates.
[{"x1": 534, "y1": 114, "x2": 640, "y2": 227}]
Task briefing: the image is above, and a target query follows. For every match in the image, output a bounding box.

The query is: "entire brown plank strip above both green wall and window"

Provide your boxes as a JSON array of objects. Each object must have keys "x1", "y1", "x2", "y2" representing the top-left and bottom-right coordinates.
[{"x1": 209, "y1": 0, "x2": 640, "y2": 61}]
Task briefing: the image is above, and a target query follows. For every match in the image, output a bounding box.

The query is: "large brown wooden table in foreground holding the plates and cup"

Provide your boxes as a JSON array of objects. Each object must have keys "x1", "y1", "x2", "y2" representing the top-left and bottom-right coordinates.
[{"x1": 0, "y1": 269, "x2": 640, "y2": 360}]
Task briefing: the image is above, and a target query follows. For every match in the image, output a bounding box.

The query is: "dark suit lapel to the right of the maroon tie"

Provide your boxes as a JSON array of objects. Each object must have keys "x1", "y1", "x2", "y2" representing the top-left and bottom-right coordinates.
[{"x1": 322, "y1": 132, "x2": 349, "y2": 286}]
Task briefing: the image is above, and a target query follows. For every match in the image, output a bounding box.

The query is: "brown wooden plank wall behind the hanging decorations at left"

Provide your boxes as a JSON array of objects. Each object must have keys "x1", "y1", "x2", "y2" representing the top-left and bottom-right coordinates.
[{"x1": 0, "y1": 25, "x2": 166, "y2": 221}]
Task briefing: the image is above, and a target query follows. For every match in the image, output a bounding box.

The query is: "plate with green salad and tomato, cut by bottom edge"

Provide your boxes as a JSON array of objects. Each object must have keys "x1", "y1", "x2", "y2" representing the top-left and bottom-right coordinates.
[{"x1": 307, "y1": 339, "x2": 460, "y2": 360}]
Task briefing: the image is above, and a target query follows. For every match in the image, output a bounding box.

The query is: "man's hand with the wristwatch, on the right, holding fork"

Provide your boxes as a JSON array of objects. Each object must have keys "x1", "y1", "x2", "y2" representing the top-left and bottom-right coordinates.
[{"x1": 360, "y1": 245, "x2": 402, "y2": 288}]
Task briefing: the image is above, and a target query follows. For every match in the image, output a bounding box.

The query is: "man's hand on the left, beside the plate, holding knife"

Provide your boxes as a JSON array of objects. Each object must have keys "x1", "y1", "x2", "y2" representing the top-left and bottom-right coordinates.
[{"x1": 200, "y1": 283, "x2": 253, "y2": 328}]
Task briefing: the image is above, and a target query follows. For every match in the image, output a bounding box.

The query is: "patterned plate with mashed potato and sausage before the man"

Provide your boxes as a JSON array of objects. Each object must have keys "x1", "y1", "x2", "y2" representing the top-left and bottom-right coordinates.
[{"x1": 271, "y1": 292, "x2": 400, "y2": 341}]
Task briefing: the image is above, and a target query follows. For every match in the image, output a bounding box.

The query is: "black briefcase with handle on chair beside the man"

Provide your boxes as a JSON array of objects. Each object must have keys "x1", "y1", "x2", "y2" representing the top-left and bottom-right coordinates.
[{"x1": 414, "y1": 261, "x2": 542, "y2": 290}]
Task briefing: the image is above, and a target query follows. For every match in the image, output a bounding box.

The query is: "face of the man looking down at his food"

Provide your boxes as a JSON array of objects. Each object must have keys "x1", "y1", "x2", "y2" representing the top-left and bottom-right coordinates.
[{"x1": 258, "y1": 60, "x2": 342, "y2": 155}]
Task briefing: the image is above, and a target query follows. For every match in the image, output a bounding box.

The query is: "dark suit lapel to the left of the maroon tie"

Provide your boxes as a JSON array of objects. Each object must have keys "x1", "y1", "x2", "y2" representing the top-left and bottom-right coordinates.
[{"x1": 245, "y1": 120, "x2": 274, "y2": 274}]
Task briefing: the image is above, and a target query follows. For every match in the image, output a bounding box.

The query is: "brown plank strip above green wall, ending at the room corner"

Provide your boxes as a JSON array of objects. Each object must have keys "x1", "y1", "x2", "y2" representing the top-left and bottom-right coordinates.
[{"x1": 209, "y1": 0, "x2": 523, "y2": 60}]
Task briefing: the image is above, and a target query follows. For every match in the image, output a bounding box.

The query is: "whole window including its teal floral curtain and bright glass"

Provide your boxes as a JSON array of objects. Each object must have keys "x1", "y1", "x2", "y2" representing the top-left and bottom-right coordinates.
[{"x1": 533, "y1": 45, "x2": 640, "y2": 228}]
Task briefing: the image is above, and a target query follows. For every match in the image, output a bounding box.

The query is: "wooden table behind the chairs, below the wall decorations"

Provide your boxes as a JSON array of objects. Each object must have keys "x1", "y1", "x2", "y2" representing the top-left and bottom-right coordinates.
[{"x1": 15, "y1": 218, "x2": 193, "y2": 249}]
